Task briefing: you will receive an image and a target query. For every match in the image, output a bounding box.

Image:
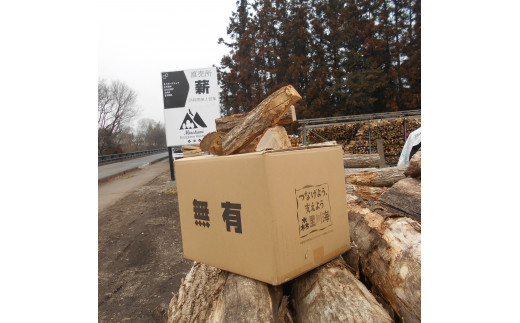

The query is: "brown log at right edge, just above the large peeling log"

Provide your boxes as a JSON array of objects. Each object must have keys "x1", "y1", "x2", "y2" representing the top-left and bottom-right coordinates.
[{"x1": 379, "y1": 177, "x2": 421, "y2": 222}]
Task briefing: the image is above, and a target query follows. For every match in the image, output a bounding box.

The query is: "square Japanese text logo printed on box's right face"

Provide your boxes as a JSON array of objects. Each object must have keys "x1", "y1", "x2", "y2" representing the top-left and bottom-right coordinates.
[{"x1": 295, "y1": 183, "x2": 332, "y2": 238}]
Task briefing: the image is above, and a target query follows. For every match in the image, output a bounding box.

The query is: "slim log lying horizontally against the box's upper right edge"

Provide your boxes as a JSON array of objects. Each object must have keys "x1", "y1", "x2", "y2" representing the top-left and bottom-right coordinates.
[{"x1": 345, "y1": 166, "x2": 408, "y2": 187}]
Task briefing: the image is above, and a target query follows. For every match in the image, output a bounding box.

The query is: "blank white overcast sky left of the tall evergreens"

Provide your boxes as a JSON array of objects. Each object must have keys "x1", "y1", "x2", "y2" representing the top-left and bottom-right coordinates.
[{"x1": 98, "y1": 0, "x2": 236, "y2": 129}]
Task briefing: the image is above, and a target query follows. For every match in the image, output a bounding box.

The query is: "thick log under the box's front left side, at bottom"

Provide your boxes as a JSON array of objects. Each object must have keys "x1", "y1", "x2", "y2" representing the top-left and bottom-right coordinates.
[{"x1": 168, "y1": 262, "x2": 288, "y2": 323}]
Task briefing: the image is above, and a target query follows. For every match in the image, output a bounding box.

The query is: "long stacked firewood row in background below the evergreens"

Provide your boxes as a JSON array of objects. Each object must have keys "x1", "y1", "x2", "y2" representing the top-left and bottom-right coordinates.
[{"x1": 307, "y1": 118, "x2": 421, "y2": 165}]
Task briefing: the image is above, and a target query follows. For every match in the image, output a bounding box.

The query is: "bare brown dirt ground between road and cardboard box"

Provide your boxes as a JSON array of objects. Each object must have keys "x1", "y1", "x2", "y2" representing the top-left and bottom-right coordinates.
[{"x1": 98, "y1": 170, "x2": 192, "y2": 322}]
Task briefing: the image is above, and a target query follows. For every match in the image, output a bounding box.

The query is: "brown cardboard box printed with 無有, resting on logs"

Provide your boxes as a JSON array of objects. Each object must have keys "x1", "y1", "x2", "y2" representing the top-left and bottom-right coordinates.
[{"x1": 175, "y1": 145, "x2": 350, "y2": 285}]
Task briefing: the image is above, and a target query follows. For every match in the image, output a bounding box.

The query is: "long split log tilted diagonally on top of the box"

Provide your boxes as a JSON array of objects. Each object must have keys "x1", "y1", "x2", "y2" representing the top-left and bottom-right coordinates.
[{"x1": 222, "y1": 85, "x2": 302, "y2": 155}]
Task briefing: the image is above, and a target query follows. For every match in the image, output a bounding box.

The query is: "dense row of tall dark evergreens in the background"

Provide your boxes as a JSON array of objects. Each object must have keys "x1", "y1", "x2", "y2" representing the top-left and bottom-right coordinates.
[{"x1": 219, "y1": 0, "x2": 421, "y2": 118}]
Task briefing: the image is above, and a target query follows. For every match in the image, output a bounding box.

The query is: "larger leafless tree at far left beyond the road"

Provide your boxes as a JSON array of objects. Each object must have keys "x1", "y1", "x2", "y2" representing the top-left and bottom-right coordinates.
[{"x1": 98, "y1": 80, "x2": 140, "y2": 155}]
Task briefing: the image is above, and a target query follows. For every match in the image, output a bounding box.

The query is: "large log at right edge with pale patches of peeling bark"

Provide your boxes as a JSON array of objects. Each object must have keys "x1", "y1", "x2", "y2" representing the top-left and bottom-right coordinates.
[{"x1": 348, "y1": 203, "x2": 421, "y2": 322}]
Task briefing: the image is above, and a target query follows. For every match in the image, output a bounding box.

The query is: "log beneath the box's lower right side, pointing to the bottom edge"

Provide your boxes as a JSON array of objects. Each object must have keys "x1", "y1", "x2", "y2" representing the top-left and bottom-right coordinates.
[{"x1": 291, "y1": 258, "x2": 393, "y2": 323}]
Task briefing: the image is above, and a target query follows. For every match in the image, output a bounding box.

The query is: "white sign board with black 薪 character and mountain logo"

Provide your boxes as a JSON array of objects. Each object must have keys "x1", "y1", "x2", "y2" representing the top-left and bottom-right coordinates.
[{"x1": 161, "y1": 67, "x2": 220, "y2": 147}]
